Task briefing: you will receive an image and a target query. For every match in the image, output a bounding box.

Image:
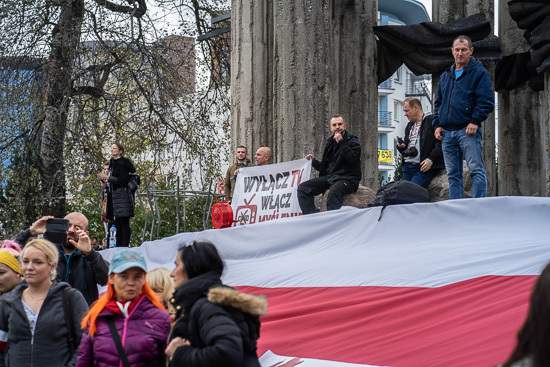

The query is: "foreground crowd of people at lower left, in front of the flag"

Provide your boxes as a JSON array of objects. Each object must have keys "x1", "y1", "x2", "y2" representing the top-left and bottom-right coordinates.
[{"x1": 0, "y1": 229, "x2": 267, "y2": 367}]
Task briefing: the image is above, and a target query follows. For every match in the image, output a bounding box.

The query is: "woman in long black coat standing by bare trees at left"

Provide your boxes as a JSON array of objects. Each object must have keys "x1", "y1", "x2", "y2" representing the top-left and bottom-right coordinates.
[{"x1": 97, "y1": 142, "x2": 136, "y2": 247}]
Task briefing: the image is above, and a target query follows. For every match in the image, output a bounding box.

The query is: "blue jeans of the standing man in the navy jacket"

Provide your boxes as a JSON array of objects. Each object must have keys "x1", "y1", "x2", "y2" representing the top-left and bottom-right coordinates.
[{"x1": 441, "y1": 128, "x2": 487, "y2": 199}]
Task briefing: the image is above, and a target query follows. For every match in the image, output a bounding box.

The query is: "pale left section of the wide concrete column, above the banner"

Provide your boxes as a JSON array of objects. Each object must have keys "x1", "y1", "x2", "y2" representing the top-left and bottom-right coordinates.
[{"x1": 231, "y1": 0, "x2": 273, "y2": 152}]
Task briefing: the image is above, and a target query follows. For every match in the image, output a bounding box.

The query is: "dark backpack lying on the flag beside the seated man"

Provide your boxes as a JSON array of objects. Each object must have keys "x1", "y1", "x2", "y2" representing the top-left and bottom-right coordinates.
[{"x1": 368, "y1": 180, "x2": 430, "y2": 220}]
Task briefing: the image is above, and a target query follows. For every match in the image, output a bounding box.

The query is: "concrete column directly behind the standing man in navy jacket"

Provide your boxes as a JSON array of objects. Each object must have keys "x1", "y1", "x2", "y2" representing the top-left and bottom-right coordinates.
[{"x1": 432, "y1": 0, "x2": 497, "y2": 196}]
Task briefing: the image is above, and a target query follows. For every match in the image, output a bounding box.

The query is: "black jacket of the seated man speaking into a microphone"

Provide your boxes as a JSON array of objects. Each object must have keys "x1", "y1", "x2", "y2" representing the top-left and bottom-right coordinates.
[{"x1": 311, "y1": 131, "x2": 361, "y2": 185}]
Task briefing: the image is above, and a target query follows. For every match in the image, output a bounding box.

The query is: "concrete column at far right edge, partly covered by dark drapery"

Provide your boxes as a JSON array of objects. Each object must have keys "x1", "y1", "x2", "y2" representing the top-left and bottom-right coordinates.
[{"x1": 498, "y1": 0, "x2": 547, "y2": 196}]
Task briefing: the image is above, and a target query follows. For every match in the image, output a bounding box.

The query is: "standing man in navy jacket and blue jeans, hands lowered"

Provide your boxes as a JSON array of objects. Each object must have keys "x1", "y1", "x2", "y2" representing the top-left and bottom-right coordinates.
[{"x1": 433, "y1": 36, "x2": 495, "y2": 199}]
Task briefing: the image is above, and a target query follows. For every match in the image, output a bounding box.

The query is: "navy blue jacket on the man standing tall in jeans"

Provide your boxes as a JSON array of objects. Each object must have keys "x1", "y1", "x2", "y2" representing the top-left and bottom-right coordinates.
[{"x1": 433, "y1": 57, "x2": 495, "y2": 130}]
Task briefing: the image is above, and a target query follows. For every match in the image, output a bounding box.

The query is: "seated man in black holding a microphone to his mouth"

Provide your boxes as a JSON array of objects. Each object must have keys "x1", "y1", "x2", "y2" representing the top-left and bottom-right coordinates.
[{"x1": 298, "y1": 115, "x2": 361, "y2": 214}]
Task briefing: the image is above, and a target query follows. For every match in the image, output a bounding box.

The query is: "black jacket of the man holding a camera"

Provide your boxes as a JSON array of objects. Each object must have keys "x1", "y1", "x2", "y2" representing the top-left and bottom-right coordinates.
[{"x1": 397, "y1": 114, "x2": 445, "y2": 171}]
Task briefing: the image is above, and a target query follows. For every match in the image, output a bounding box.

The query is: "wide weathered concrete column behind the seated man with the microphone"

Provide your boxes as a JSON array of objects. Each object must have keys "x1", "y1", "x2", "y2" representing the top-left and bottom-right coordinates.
[{"x1": 231, "y1": 0, "x2": 378, "y2": 189}]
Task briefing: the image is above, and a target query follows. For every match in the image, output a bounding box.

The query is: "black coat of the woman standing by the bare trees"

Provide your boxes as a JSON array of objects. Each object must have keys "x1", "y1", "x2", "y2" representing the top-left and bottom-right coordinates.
[{"x1": 106, "y1": 157, "x2": 136, "y2": 220}]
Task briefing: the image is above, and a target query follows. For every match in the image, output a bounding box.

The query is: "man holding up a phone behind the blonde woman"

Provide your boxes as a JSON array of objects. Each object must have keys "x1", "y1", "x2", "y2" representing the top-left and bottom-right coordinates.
[{"x1": 15, "y1": 212, "x2": 109, "y2": 305}]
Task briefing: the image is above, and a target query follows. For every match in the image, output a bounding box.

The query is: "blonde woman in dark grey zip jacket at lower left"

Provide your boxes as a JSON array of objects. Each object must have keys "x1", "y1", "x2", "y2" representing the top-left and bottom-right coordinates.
[{"x1": 0, "y1": 239, "x2": 88, "y2": 367}]
